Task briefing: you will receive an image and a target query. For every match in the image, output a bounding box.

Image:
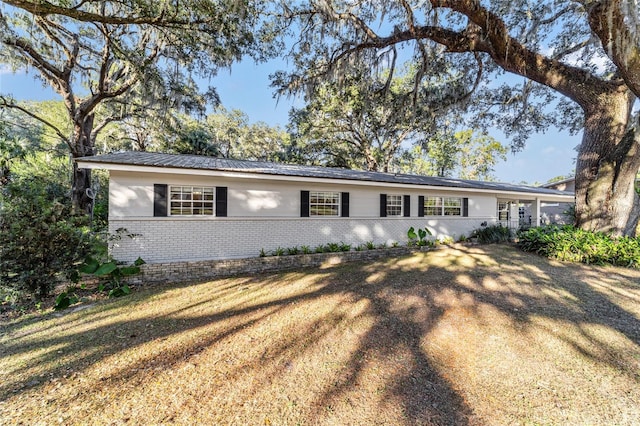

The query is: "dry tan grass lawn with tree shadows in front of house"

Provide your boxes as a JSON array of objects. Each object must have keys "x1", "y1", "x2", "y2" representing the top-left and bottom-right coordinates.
[{"x1": 0, "y1": 246, "x2": 640, "y2": 425}]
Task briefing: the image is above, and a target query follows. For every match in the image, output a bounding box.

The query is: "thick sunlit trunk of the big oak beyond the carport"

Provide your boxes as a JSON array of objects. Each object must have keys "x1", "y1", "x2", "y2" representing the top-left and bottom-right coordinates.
[{"x1": 576, "y1": 91, "x2": 640, "y2": 236}]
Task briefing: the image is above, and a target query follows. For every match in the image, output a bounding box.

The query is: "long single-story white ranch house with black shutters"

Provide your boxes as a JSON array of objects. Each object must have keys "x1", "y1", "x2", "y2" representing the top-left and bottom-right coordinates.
[{"x1": 76, "y1": 152, "x2": 574, "y2": 263}]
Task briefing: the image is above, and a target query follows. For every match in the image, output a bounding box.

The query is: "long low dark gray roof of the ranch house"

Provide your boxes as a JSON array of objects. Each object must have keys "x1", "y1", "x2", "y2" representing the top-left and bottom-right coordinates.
[{"x1": 77, "y1": 151, "x2": 569, "y2": 196}]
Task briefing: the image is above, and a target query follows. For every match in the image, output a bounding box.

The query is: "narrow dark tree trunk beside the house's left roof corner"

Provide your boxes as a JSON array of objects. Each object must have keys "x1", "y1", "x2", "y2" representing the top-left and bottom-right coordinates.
[{"x1": 71, "y1": 114, "x2": 94, "y2": 214}]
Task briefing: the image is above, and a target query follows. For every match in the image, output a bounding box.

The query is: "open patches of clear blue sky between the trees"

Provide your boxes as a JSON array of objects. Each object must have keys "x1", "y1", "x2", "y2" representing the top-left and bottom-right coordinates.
[{"x1": 0, "y1": 60, "x2": 580, "y2": 184}]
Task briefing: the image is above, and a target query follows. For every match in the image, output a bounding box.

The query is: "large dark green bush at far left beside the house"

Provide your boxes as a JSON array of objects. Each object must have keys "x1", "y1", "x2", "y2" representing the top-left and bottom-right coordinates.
[{"x1": 0, "y1": 175, "x2": 96, "y2": 298}]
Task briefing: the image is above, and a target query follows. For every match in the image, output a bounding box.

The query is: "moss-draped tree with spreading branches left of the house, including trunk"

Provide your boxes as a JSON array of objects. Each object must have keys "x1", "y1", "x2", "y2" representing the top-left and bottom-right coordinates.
[{"x1": 0, "y1": 0, "x2": 264, "y2": 210}]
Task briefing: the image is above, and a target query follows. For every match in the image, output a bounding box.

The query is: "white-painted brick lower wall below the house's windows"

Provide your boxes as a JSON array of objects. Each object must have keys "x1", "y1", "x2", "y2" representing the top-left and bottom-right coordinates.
[{"x1": 109, "y1": 217, "x2": 495, "y2": 263}]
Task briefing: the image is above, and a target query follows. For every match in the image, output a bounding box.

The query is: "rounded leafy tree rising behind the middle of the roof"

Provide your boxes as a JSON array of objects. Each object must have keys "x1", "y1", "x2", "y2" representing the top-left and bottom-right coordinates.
[{"x1": 290, "y1": 66, "x2": 464, "y2": 172}]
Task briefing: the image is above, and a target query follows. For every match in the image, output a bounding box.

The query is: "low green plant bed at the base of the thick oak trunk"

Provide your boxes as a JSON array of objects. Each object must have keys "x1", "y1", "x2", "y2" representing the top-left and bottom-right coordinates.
[{"x1": 518, "y1": 225, "x2": 640, "y2": 268}]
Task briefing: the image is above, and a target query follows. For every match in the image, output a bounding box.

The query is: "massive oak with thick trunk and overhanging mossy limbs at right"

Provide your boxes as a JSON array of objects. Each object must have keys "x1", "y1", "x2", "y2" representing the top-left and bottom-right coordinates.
[{"x1": 279, "y1": 0, "x2": 640, "y2": 235}]
